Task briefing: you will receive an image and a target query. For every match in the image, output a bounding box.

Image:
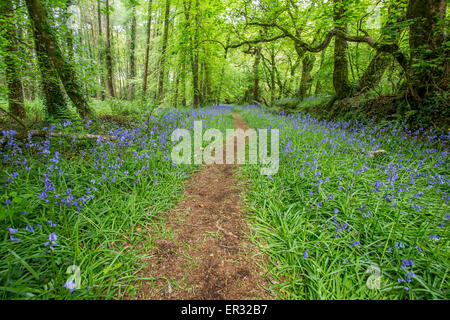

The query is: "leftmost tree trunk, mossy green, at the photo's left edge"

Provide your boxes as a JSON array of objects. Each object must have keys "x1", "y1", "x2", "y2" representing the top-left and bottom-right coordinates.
[{"x1": 0, "y1": 0, "x2": 27, "y2": 119}]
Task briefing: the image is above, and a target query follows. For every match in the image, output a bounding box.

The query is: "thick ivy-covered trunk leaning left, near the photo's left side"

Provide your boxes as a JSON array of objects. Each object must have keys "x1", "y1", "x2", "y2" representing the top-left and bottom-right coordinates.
[{"x1": 26, "y1": 0, "x2": 90, "y2": 117}]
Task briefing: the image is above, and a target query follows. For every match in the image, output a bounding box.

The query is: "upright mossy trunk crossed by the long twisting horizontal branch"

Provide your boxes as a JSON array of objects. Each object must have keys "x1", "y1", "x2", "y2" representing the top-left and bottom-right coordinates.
[{"x1": 333, "y1": 0, "x2": 350, "y2": 99}]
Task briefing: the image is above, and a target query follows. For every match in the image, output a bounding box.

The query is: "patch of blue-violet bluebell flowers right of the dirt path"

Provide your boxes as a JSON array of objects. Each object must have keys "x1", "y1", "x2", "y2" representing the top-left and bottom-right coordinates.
[{"x1": 242, "y1": 106, "x2": 450, "y2": 298}]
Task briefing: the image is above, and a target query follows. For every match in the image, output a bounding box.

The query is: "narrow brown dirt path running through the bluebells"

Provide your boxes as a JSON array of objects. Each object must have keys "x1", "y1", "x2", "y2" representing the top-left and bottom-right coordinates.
[{"x1": 137, "y1": 113, "x2": 271, "y2": 300}]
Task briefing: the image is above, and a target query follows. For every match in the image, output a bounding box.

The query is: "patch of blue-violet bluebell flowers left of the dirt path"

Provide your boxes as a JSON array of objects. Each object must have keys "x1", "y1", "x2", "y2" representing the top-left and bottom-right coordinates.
[{"x1": 0, "y1": 106, "x2": 231, "y2": 291}]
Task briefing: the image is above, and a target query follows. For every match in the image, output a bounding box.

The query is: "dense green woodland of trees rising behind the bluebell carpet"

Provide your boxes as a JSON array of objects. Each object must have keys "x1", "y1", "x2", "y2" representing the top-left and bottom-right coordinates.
[{"x1": 0, "y1": 0, "x2": 450, "y2": 124}]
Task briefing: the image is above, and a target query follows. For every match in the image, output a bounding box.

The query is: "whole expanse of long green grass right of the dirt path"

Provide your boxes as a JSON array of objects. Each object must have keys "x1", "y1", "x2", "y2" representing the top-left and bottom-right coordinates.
[{"x1": 240, "y1": 108, "x2": 450, "y2": 299}]
